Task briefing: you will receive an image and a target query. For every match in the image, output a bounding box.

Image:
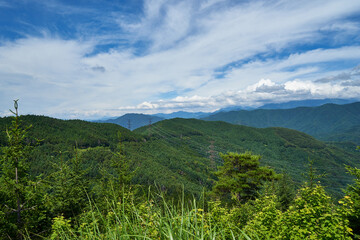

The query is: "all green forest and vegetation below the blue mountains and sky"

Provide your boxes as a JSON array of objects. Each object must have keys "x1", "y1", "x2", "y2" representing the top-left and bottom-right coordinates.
[{"x1": 0, "y1": 102, "x2": 360, "y2": 239}]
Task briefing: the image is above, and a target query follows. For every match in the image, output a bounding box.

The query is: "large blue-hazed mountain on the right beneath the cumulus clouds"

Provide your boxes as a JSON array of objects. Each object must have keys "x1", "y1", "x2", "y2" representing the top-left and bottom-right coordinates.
[{"x1": 203, "y1": 102, "x2": 360, "y2": 144}]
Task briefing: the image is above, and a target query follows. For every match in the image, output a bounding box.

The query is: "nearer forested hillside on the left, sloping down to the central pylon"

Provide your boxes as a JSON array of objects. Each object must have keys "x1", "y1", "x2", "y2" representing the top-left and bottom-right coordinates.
[{"x1": 0, "y1": 115, "x2": 211, "y2": 193}]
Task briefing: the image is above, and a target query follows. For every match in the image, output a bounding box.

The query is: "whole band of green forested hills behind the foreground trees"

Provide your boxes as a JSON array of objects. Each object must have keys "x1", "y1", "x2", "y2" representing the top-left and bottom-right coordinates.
[{"x1": 0, "y1": 116, "x2": 360, "y2": 198}]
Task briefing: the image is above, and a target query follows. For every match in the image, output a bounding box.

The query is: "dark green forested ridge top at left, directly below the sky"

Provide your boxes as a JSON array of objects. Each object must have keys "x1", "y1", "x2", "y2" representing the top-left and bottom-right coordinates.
[{"x1": 0, "y1": 115, "x2": 140, "y2": 148}]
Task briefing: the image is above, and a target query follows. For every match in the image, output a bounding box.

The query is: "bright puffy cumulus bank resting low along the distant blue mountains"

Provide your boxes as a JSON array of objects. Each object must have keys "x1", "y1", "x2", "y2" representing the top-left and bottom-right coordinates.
[{"x1": 112, "y1": 74, "x2": 360, "y2": 116}]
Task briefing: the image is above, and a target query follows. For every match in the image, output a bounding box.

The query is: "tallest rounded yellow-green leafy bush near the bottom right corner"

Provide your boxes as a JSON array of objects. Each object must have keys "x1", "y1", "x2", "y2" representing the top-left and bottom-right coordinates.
[{"x1": 279, "y1": 185, "x2": 352, "y2": 239}]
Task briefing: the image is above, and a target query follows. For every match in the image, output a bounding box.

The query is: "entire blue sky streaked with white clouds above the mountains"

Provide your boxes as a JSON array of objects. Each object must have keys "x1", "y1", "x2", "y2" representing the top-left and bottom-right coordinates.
[{"x1": 0, "y1": 0, "x2": 360, "y2": 119}]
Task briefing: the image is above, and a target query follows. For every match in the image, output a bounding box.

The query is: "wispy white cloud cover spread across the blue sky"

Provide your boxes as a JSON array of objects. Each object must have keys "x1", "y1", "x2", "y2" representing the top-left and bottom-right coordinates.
[{"x1": 0, "y1": 0, "x2": 360, "y2": 116}]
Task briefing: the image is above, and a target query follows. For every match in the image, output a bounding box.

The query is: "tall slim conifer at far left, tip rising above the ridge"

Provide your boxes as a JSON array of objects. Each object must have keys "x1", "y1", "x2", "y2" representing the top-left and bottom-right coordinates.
[{"x1": 0, "y1": 100, "x2": 44, "y2": 239}]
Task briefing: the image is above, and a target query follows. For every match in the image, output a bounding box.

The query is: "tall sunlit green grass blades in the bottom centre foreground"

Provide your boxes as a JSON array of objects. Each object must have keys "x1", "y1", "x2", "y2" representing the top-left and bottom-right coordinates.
[{"x1": 43, "y1": 187, "x2": 250, "y2": 240}]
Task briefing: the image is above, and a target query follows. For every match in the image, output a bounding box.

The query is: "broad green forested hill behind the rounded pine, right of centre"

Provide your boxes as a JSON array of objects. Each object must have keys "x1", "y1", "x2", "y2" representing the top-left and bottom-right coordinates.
[{"x1": 135, "y1": 119, "x2": 360, "y2": 197}]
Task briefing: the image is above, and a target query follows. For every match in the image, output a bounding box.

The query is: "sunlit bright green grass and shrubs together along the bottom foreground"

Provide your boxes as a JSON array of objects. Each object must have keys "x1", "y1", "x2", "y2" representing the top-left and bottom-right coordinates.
[{"x1": 43, "y1": 182, "x2": 351, "y2": 239}]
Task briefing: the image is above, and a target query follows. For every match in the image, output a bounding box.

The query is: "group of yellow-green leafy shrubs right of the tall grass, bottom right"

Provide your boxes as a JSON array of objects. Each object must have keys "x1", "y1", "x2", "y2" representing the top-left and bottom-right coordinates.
[{"x1": 245, "y1": 185, "x2": 352, "y2": 239}]
